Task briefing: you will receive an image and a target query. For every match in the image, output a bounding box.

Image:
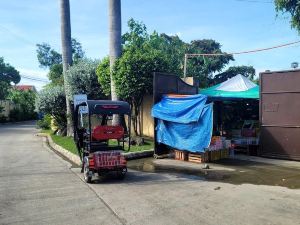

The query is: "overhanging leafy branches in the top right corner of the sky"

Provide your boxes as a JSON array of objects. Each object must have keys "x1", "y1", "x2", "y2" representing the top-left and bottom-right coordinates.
[{"x1": 275, "y1": 0, "x2": 300, "y2": 32}]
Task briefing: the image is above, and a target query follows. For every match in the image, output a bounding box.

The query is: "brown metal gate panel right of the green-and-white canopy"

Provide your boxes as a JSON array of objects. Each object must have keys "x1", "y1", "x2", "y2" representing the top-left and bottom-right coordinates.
[{"x1": 260, "y1": 70, "x2": 300, "y2": 160}]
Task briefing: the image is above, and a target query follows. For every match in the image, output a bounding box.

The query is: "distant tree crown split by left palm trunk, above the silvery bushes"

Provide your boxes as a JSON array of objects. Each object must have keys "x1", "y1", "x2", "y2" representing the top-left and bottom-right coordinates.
[{"x1": 36, "y1": 38, "x2": 84, "y2": 68}]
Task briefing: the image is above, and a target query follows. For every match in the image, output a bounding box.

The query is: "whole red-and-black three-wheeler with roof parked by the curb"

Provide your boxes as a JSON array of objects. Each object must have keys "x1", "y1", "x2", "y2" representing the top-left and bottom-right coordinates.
[{"x1": 74, "y1": 100, "x2": 131, "y2": 183}]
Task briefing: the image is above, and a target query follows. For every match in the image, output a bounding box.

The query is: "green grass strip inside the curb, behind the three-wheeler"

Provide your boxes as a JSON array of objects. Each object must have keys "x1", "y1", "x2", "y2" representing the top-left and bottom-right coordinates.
[{"x1": 42, "y1": 130, "x2": 154, "y2": 155}]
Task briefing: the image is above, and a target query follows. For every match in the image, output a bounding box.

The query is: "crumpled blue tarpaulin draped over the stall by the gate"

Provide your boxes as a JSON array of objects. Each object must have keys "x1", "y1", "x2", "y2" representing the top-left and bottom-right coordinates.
[{"x1": 152, "y1": 94, "x2": 213, "y2": 152}]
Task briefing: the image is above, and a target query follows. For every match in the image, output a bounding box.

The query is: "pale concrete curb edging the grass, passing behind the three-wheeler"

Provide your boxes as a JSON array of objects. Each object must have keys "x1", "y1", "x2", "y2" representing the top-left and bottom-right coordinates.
[{"x1": 37, "y1": 133, "x2": 154, "y2": 165}]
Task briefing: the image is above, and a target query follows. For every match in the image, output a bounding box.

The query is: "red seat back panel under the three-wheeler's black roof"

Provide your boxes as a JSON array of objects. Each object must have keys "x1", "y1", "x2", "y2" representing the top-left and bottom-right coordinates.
[{"x1": 92, "y1": 125, "x2": 124, "y2": 141}]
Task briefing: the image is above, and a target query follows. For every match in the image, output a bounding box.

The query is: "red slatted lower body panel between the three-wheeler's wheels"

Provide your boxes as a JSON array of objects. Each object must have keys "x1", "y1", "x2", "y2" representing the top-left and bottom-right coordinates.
[{"x1": 93, "y1": 151, "x2": 127, "y2": 169}]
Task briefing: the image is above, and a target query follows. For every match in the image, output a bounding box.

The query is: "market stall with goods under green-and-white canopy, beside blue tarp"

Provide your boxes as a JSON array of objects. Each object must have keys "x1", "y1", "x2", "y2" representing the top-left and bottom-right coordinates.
[{"x1": 200, "y1": 75, "x2": 259, "y2": 155}]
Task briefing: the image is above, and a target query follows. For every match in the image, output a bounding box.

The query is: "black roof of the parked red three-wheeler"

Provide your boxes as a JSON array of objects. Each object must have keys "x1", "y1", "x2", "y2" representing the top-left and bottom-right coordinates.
[{"x1": 81, "y1": 100, "x2": 131, "y2": 115}]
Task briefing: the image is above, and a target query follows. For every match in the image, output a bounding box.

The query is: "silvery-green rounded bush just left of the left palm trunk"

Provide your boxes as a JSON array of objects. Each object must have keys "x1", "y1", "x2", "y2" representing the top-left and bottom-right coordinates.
[{"x1": 36, "y1": 86, "x2": 67, "y2": 129}]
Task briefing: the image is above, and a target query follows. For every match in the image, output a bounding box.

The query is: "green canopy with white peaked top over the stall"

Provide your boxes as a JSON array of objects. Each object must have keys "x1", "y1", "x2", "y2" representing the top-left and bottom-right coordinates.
[{"x1": 200, "y1": 74, "x2": 259, "y2": 99}]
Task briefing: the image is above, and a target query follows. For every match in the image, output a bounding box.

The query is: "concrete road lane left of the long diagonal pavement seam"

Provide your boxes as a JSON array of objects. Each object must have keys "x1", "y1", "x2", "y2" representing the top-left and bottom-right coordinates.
[{"x1": 0, "y1": 123, "x2": 122, "y2": 225}]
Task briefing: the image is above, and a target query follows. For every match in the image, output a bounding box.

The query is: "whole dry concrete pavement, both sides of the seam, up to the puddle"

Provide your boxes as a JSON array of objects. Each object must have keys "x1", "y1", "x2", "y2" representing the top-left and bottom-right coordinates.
[{"x1": 0, "y1": 125, "x2": 300, "y2": 225}]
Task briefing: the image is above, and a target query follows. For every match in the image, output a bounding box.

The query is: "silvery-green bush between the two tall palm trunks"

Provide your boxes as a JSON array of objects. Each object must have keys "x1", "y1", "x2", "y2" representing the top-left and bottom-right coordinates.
[{"x1": 66, "y1": 59, "x2": 103, "y2": 99}]
